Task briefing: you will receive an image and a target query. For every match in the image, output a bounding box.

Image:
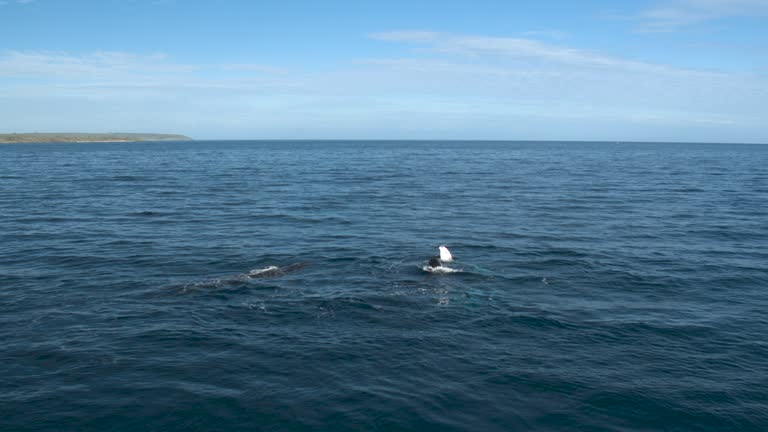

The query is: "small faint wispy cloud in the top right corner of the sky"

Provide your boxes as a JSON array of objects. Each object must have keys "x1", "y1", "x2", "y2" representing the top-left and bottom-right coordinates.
[{"x1": 638, "y1": 0, "x2": 768, "y2": 31}]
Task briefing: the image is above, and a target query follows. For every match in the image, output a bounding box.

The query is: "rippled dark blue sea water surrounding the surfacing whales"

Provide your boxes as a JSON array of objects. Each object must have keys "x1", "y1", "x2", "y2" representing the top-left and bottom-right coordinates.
[{"x1": 0, "y1": 141, "x2": 768, "y2": 431}]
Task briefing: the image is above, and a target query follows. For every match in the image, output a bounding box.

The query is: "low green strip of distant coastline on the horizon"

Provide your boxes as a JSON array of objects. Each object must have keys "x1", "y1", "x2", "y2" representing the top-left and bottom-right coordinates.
[{"x1": 0, "y1": 133, "x2": 192, "y2": 144}]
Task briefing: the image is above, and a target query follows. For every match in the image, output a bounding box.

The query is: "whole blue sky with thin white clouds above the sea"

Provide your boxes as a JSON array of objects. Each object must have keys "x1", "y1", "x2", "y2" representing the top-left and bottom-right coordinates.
[{"x1": 0, "y1": 0, "x2": 768, "y2": 143}]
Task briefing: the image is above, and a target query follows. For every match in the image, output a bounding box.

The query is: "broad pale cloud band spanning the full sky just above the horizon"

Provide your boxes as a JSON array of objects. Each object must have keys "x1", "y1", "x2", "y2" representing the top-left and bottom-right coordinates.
[{"x1": 0, "y1": 31, "x2": 768, "y2": 141}]
